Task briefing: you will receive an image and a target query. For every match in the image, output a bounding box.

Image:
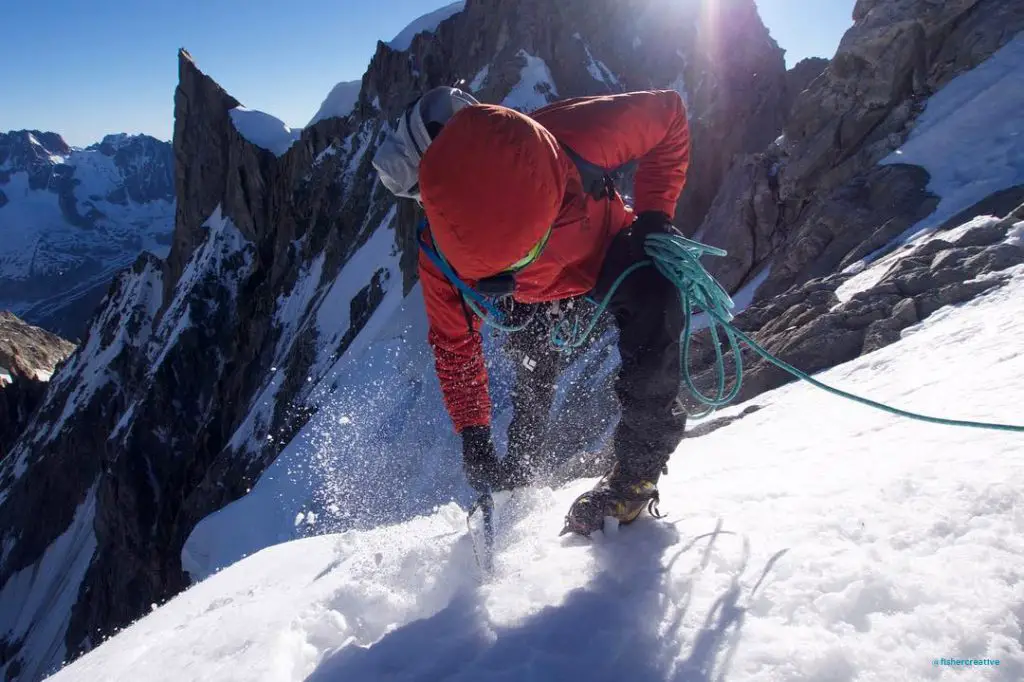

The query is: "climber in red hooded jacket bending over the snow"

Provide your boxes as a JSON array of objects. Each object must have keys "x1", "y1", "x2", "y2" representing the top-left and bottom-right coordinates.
[{"x1": 374, "y1": 83, "x2": 689, "y2": 535}]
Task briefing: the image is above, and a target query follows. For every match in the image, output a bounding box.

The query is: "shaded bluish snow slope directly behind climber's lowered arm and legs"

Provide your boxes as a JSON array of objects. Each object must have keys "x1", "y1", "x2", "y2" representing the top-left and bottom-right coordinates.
[{"x1": 181, "y1": 274, "x2": 618, "y2": 580}]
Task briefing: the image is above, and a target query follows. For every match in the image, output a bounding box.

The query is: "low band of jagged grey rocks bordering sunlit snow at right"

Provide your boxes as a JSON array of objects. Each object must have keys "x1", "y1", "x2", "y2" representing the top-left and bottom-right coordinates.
[{"x1": 692, "y1": 206, "x2": 1024, "y2": 408}]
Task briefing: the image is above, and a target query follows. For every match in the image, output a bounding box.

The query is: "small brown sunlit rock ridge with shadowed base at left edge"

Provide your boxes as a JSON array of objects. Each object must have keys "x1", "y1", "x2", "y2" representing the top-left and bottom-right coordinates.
[{"x1": 0, "y1": 312, "x2": 75, "y2": 460}]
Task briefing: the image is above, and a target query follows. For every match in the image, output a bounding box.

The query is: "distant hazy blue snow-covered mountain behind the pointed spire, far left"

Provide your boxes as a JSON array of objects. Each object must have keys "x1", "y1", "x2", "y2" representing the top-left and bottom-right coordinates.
[{"x1": 0, "y1": 130, "x2": 174, "y2": 338}]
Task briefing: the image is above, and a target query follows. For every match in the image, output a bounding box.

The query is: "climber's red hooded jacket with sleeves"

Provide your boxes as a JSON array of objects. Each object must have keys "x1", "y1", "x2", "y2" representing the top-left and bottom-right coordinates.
[{"x1": 419, "y1": 90, "x2": 690, "y2": 431}]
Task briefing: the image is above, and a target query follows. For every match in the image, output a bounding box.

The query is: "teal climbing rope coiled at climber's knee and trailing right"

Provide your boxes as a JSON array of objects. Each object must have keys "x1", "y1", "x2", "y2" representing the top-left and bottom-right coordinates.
[{"x1": 470, "y1": 228, "x2": 1024, "y2": 432}]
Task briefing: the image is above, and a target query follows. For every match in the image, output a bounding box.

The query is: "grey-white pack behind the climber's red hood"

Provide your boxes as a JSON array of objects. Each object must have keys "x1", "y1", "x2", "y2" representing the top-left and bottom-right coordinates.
[{"x1": 373, "y1": 86, "x2": 480, "y2": 201}]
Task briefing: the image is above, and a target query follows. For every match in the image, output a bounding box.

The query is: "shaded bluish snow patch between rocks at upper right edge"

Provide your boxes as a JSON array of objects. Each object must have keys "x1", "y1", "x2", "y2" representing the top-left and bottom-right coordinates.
[{"x1": 880, "y1": 33, "x2": 1024, "y2": 242}]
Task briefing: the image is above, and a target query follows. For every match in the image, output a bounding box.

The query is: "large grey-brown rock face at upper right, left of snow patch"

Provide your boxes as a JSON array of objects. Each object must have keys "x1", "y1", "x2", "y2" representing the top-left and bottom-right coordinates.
[{"x1": 699, "y1": 0, "x2": 1024, "y2": 298}]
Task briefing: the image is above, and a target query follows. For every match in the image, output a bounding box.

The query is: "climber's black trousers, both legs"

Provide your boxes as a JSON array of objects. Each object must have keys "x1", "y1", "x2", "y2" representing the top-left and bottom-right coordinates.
[{"x1": 507, "y1": 235, "x2": 686, "y2": 479}]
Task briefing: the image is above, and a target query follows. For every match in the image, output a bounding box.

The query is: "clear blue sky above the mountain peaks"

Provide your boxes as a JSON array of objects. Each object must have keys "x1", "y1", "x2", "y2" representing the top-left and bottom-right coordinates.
[{"x1": 0, "y1": 0, "x2": 854, "y2": 145}]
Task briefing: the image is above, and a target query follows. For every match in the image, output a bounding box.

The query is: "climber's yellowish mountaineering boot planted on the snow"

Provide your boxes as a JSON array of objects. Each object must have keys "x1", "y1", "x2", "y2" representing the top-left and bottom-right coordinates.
[{"x1": 558, "y1": 463, "x2": 662, "y2": 536}]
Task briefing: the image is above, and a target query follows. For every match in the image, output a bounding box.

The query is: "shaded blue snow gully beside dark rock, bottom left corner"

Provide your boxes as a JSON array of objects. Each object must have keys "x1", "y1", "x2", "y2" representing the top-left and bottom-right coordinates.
[{"x1": 0, "y1": 483, "x2": 96, "y2": 680}]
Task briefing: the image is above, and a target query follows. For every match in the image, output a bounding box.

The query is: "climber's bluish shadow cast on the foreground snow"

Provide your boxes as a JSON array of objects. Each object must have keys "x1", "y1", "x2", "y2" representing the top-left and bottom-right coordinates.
[{"x1": 306, "y1": 521, "x2": 786, "y2": 682}]
